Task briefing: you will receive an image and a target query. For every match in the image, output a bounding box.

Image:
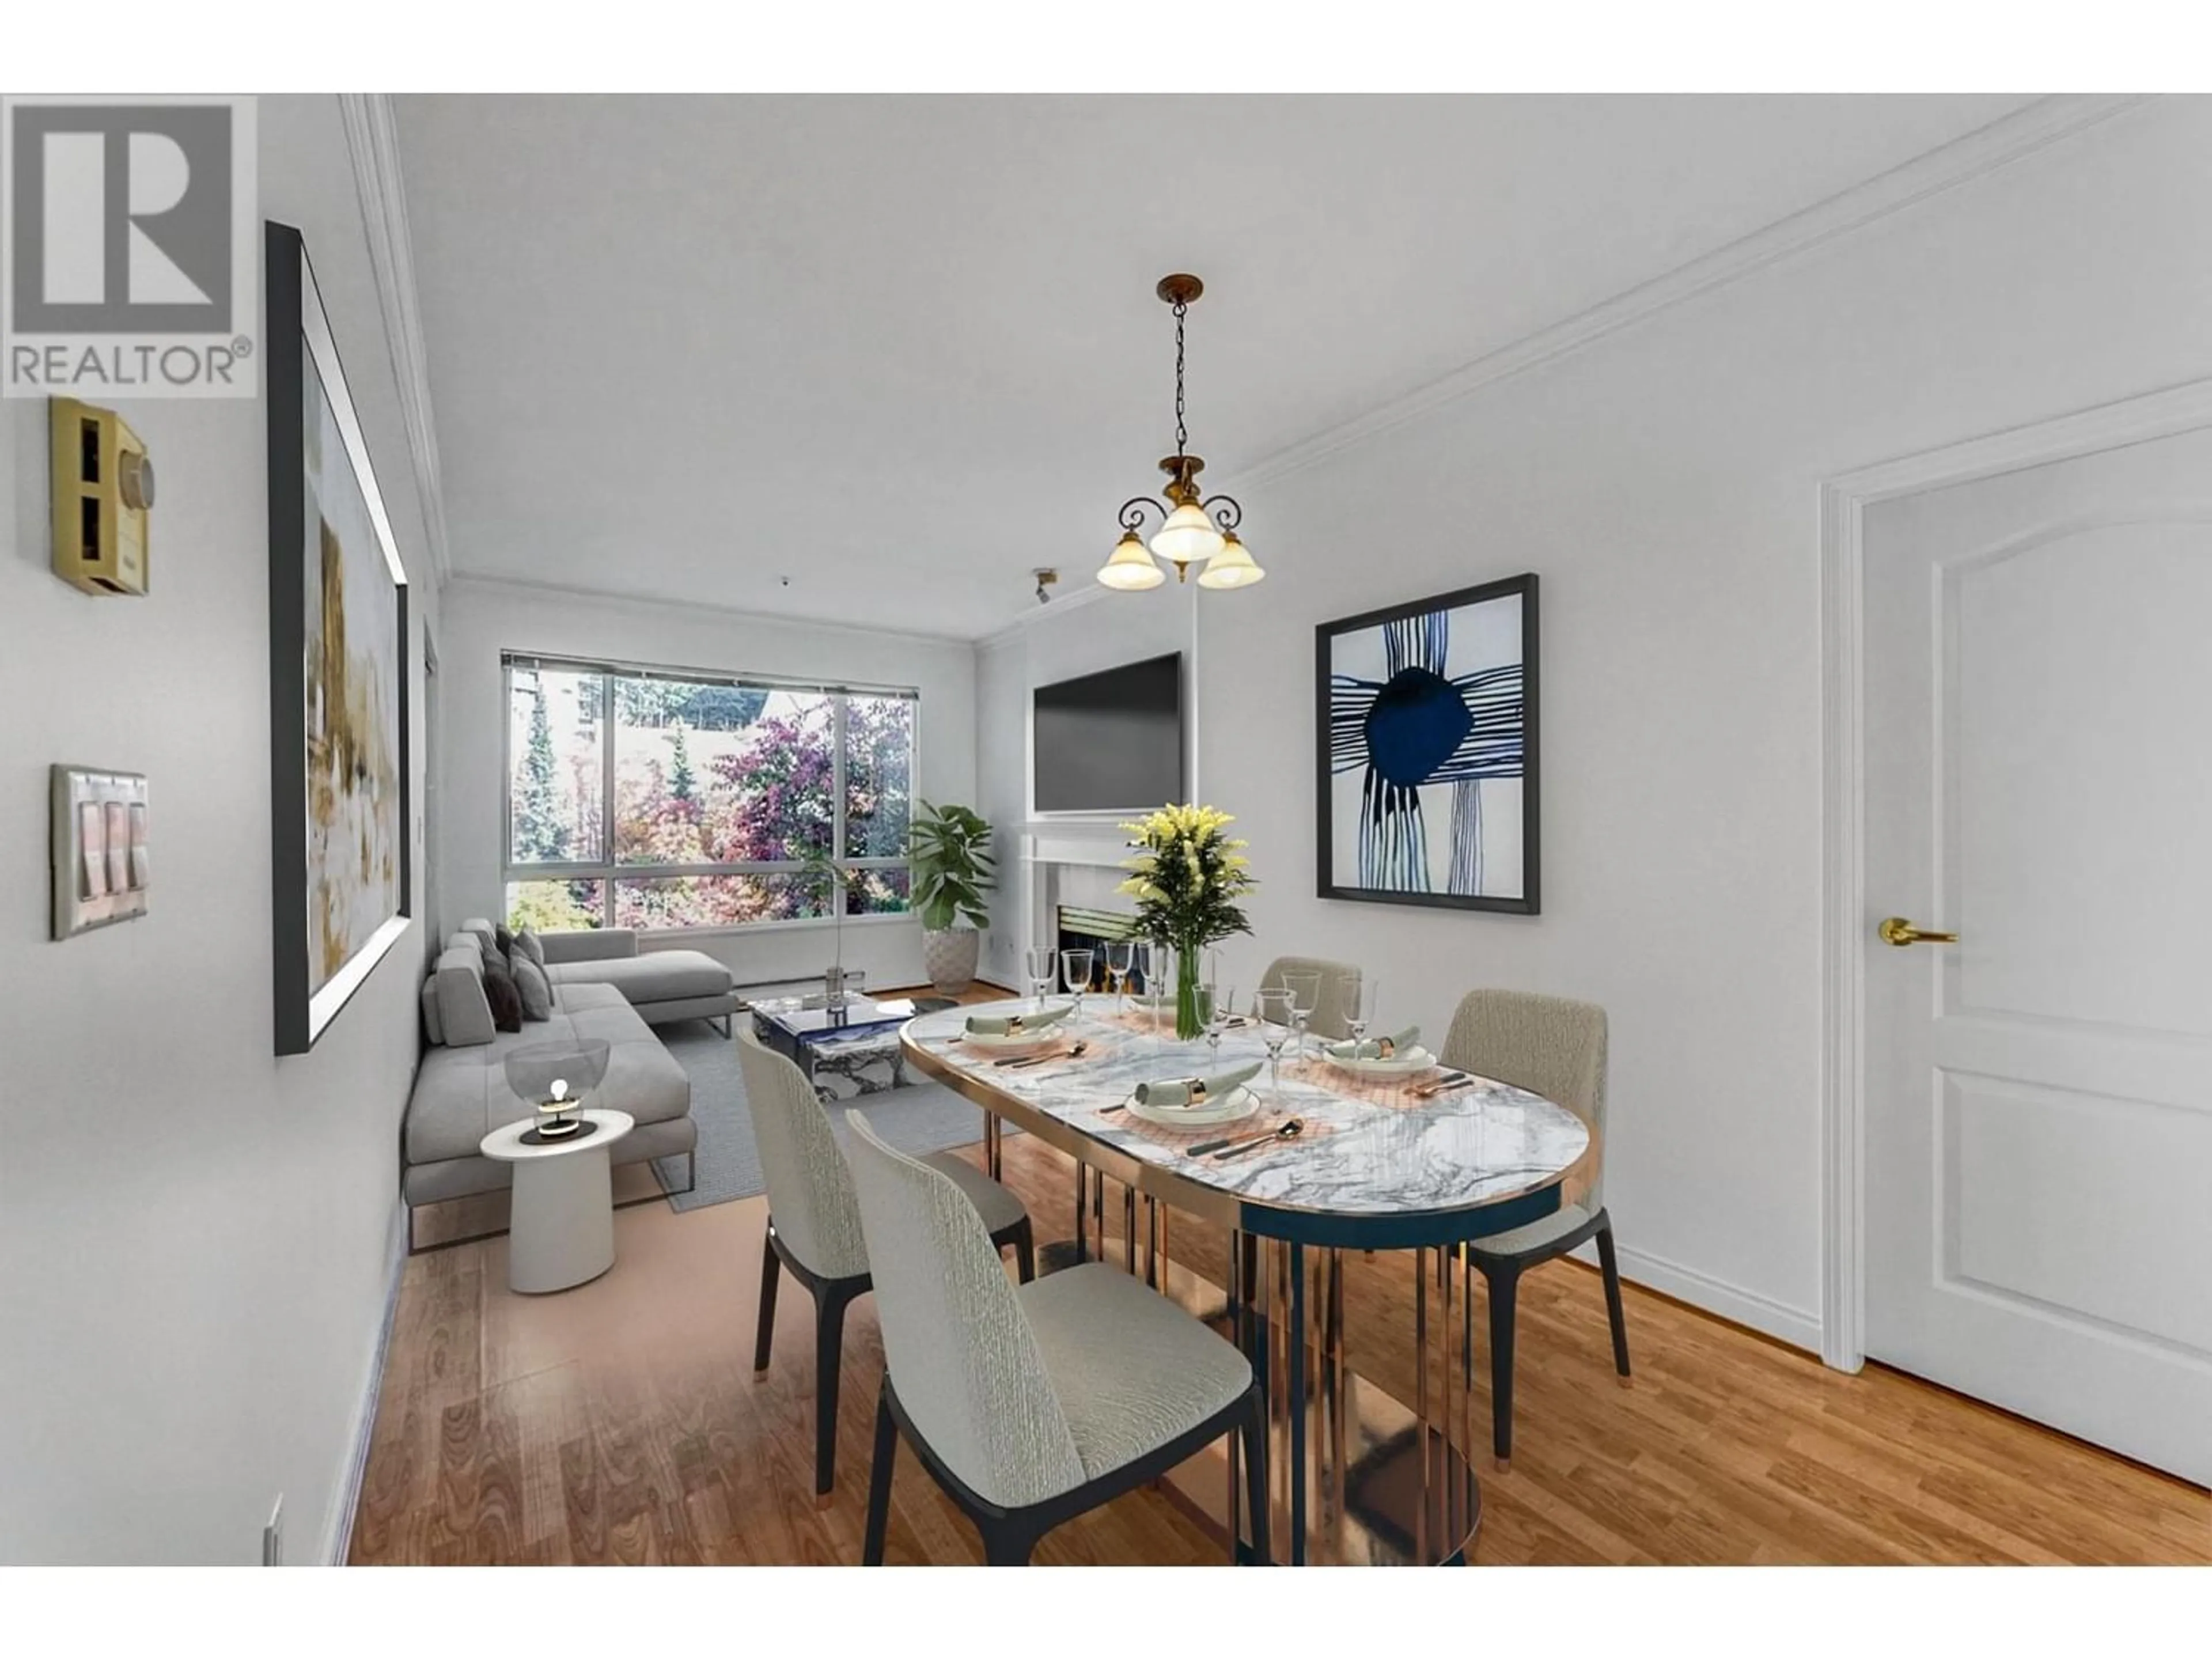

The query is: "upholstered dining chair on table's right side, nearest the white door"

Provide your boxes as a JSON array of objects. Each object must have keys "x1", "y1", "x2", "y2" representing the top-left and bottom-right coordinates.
[{"x1": 1442, "y1": 991, "x2": 1628, "y2": 1469}]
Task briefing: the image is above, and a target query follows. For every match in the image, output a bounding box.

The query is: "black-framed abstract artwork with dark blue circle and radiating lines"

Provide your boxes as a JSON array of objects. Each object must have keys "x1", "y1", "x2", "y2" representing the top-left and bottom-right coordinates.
[{"x1": 1314, "y1": 575, "x2": 1537, "y2": 916}]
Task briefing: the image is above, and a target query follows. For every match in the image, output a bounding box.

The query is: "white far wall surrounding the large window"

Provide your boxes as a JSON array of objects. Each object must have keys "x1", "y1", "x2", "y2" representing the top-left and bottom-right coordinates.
[{"x1": 438, "y1": 582, "x2": 975, "y2": 987}]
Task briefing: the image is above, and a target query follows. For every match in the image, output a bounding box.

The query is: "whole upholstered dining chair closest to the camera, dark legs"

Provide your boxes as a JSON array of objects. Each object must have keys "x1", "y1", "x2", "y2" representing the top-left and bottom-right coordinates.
[{"x1": 845, "y1": 1113, "x2": 1267, "y2": 1566}]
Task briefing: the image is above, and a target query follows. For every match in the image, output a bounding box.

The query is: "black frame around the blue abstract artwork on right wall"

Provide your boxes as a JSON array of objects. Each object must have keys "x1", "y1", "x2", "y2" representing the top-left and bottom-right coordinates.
[{"x1": 1314, "y1": 573, "x2": 1541, "y2": 916}]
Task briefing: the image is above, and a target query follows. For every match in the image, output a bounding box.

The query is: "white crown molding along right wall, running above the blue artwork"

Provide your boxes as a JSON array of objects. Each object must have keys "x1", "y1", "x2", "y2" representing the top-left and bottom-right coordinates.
[{"x1": 1230, "y1": 93, "x2": 2152, "y2": 489}]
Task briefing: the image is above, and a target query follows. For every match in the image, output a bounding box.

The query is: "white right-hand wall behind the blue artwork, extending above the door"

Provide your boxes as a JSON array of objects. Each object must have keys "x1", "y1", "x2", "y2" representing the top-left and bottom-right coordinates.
[{"x1": 982, "y1": 100, "x2": 2212, "y2": 1345}]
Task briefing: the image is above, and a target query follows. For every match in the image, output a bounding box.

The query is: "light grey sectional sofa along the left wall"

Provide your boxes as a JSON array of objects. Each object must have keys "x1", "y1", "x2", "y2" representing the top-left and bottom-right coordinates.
[{"x1": 400, "y1": 920, "x2": 707, "y2": 1252}]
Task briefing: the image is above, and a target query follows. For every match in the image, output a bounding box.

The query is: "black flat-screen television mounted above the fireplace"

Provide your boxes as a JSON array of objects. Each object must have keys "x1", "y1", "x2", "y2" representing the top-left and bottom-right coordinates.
[{"x1": 1031, "y1": 653, "x2": 1183, "y2": 812}]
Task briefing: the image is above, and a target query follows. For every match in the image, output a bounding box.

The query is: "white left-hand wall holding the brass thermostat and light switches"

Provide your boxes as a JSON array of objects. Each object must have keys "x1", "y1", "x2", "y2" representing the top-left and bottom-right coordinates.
[{"x1": 0, "y1": 97, "x2": 435, "y2": 1562}]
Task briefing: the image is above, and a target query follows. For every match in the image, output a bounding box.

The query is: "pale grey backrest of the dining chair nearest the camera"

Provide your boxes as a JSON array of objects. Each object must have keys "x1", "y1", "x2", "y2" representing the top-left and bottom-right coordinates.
[{"x1": 845, "y1": 1111, "x2": 1084, "y2": 1509}]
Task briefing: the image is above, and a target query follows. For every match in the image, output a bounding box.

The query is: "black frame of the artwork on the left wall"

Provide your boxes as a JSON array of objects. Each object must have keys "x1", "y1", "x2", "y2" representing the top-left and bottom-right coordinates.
[{"x1": 261, "y1": 221, "x2": 414, "y2": 1055}]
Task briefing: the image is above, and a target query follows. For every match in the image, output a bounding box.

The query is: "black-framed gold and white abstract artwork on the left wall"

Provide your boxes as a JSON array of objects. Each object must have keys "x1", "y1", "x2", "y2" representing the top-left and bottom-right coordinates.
[{"x1": 263, "y1": 224, "x2": 411, "y2": 1055}]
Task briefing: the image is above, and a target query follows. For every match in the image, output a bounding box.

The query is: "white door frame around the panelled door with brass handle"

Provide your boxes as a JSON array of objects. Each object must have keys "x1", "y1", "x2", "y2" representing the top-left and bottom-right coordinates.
[{"x1": 1820, "y1": 380, "x2": 2212, "y2": 1372}]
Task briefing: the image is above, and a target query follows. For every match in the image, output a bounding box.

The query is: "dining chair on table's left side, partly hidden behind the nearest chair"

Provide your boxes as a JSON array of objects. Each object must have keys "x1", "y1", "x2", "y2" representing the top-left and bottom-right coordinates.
[{"x1": 737, "y1": 1031, "x2": 1035, "y2": 1504}]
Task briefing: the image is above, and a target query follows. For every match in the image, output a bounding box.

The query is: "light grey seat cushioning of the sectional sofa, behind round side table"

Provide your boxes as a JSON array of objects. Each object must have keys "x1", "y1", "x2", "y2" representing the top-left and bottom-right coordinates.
[{"x1": 407, "y1": 987, "x2": 690, "y2": 1164}]
